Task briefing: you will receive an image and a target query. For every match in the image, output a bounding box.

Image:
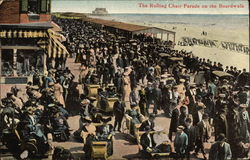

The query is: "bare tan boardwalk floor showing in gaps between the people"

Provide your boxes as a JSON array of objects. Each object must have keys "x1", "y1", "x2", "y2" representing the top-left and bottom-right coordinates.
[{"x1": 50, "y1": 58, "x2": 210, "y2": 160}]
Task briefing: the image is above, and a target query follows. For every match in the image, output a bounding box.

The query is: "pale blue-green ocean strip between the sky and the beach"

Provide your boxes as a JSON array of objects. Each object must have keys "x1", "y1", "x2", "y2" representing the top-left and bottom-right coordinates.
[{"x1": 89, "y1": 14, "x2": 249, "y2": 32}]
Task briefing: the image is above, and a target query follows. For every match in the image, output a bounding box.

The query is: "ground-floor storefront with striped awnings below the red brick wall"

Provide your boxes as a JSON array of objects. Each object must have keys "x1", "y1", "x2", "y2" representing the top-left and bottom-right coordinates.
[{"x1": 0, "y1": 23, "x2": 68, "y2": 84}]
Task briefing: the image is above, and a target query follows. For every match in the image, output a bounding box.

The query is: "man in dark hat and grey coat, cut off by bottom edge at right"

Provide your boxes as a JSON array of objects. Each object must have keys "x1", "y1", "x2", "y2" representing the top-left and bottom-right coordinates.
[{"x1": 209, "y1": 133, "x2": 232, "y2": 160}]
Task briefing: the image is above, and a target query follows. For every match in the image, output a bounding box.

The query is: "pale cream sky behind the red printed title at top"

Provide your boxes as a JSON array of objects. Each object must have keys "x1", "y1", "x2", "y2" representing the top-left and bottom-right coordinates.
[{"x1": 52, "y1": 0, "x2": 249, "y2": 14}]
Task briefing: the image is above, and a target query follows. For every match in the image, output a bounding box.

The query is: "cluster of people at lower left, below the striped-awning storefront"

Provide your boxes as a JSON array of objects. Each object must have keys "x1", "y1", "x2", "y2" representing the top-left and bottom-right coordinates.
[{"x1": 0, "y1": 68, "x2": 74, "y2": 159}]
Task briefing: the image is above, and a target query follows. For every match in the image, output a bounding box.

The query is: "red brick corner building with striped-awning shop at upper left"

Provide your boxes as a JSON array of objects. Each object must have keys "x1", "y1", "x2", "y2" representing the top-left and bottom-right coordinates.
[{"x1": 0, "y1": 0, "x2": 68, "y2": 88}]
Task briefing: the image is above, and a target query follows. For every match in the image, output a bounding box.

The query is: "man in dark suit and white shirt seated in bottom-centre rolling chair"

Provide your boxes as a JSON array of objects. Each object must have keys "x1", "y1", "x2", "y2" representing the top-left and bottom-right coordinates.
[{"x1": 140, "y1": 126, "x2": 156, "y2": 157}]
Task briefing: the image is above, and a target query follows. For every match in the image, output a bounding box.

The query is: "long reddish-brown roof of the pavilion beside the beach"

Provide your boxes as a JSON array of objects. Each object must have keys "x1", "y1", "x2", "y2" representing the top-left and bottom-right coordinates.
[{"x1": 84, "y1": 18, "x2": 152, "y2": 32}]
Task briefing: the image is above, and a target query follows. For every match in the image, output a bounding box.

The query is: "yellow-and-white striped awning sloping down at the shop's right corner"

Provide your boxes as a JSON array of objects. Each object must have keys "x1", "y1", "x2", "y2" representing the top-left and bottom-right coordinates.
[{"x1": 47, "y1": 29, "x2": 69, "y2": 58}]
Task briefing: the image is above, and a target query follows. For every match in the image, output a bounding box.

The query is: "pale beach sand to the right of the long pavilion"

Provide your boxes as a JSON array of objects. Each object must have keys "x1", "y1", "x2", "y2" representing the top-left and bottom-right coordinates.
[{"x1": 134, "y1": 23, "x2": 249, "y2": 71}]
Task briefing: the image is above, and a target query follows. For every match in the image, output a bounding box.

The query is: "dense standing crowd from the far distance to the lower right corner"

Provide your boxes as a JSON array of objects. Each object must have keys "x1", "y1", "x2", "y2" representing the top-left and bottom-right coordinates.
[{"x1": 54, "y1": 16, "x2": 250, "y2": 159}]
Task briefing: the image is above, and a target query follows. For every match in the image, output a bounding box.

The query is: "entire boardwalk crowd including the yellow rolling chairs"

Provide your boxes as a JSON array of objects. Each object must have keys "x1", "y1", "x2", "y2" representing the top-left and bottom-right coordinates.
[{"x1": 0, "y1": 17, "x2": 250, "y2": 160}]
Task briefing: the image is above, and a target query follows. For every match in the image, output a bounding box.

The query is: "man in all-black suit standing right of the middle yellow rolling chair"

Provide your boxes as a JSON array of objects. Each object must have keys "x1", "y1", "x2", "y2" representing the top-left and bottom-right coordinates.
[{"x1": 113, "y1": 95, "x2": 126, "y2": 132}]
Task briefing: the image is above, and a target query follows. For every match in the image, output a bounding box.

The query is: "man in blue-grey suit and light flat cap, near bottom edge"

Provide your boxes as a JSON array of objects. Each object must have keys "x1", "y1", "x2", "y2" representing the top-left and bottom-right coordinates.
[{"x1": 174, "y1": 126, "x2": 188, "y2": 159}]
